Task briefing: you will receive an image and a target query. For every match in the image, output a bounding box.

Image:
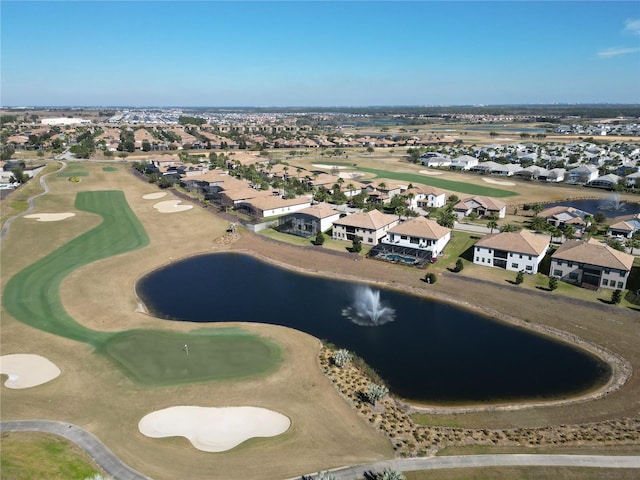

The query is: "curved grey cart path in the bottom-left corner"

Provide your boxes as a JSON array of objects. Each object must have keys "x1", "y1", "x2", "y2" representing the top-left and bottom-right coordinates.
[{"x1": 0, "y1": 420, "x2": 151, "y2": 480}]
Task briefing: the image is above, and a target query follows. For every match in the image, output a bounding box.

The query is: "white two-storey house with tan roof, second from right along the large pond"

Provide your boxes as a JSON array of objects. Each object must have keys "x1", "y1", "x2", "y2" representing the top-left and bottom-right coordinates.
[{"x1": 473, "y1": 230, "x2": 550, "y2": 273}]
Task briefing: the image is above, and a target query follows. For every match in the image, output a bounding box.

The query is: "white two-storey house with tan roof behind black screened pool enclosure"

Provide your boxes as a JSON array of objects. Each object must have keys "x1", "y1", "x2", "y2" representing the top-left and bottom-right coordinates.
[{"x1": 382, "y1": 217, "x2": 451, "y2": 257}]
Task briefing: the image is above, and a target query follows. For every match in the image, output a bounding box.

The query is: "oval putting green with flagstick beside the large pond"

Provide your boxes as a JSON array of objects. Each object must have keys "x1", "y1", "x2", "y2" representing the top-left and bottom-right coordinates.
[{"x1": 104, "y1": 329, "x2": 280, "y2": 385}]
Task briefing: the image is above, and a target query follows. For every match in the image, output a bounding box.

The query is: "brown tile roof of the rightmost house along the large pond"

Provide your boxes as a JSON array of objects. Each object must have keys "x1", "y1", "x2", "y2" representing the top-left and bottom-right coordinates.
[{"x1": 551, "y1": 238, "x2": 633, "y2": 271}]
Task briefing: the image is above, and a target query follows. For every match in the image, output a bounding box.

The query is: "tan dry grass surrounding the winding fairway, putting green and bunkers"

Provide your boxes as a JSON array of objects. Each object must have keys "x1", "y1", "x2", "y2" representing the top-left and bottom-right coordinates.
[{"x1": 0, "y1": 165, "x2": 393, "y2": 479}]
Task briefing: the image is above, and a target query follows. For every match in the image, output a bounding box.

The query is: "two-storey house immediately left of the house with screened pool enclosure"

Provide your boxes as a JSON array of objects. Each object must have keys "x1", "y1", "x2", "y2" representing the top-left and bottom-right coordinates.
[{"x1": 332, "y1": 210, "x2": 400, "y2": 245}]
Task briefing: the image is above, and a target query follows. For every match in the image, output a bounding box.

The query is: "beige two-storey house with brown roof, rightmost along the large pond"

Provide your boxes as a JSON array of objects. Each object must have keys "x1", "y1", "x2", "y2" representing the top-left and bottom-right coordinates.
[{"x1": 550, "y1": 238, "x2": 633, "y2": 290}]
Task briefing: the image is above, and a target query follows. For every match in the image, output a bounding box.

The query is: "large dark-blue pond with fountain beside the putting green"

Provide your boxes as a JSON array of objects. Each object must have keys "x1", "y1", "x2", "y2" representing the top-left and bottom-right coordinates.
[{"x1": 137, "y1": 253, "x2": 611, "y2": 404}]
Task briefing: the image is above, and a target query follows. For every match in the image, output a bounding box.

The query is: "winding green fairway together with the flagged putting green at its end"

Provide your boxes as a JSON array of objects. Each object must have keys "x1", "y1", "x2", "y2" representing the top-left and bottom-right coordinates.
[{"x1": 3, "y1": 191, "x2": 280, "y2": 384}]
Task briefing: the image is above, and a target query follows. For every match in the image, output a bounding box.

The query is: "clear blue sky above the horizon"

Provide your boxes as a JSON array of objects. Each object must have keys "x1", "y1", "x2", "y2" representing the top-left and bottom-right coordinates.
[{"x1": 0, "y1": 0, "x2": 640, "y2": 106}]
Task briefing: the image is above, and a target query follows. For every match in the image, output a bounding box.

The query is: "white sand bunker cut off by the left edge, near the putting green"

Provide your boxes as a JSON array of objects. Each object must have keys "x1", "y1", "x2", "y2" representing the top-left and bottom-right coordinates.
[{"x1": 0, "y1": 353, "x2": 60, "y2": 389}]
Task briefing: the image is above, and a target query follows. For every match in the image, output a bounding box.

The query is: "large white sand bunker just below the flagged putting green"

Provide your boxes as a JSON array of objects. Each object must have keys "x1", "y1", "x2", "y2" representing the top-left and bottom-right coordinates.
[{"x1": 138, "y1": 406, "x2": 291, "y2": 452}]
